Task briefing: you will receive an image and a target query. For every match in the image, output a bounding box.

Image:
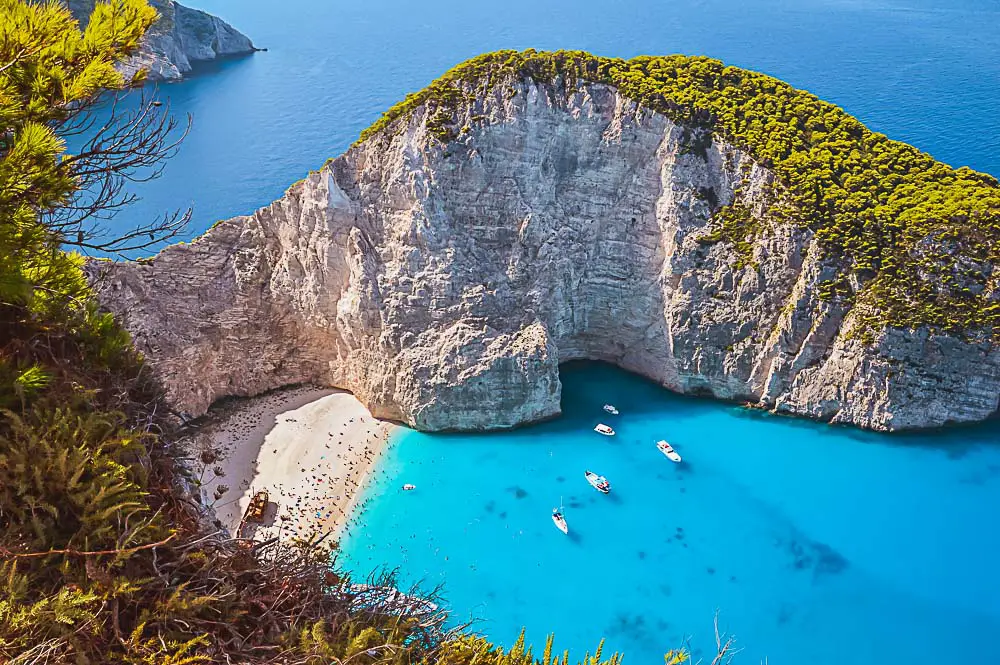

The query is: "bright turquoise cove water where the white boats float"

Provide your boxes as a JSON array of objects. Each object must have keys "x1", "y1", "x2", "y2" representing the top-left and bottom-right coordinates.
[{"x1": 340, "y1": 363, "x2": 1000, "y2": 665}]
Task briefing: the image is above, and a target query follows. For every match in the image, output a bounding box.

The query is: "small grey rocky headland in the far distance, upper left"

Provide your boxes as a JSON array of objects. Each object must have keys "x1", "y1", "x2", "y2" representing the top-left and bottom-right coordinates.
[{"x1": 64, "y1": 0, "x2": 256, "y2": 81}]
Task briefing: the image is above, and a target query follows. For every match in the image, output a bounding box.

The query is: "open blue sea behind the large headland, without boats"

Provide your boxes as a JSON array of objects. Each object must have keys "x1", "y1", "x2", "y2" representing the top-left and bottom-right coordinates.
[{"x1": 88, "y1": 0, "x2": 1000, "y2": 248}]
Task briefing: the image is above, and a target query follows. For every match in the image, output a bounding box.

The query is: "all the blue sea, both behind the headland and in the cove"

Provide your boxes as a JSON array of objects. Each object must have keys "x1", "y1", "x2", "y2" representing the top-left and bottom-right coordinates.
[{"x1": 92, "y1": 0, "x2": 1000, "y2": 665}]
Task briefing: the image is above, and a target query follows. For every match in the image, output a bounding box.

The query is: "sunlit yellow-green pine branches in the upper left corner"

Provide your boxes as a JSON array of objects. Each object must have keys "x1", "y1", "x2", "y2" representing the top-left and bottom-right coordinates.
[{"x1": 0, "y1": 0, "x2": 156, "y2": 305}]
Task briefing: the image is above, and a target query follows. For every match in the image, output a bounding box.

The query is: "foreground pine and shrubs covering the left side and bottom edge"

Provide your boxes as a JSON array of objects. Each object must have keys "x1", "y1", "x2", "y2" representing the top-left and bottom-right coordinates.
[{"x1": 0, "y1": 0, "x2": 686, "y2": 665}]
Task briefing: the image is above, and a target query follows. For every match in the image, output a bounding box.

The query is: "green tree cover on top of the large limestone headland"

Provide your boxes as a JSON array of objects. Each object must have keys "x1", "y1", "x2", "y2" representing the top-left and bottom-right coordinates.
[{"x1": 359, "y1": 50, "x2": 1000, "y2": 340}]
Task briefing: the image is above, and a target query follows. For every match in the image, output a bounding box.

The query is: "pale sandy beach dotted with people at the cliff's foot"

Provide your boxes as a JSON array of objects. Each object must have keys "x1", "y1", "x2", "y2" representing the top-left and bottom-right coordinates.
[{"x1": 186, "y1": 387, "x2": 395, "y2": 540}]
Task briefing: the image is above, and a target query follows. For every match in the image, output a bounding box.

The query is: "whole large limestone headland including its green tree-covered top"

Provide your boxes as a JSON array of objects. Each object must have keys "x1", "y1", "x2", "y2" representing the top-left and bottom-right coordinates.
[{"x1": 95, "y1": 52, "x2": 1000, "y2": 430}]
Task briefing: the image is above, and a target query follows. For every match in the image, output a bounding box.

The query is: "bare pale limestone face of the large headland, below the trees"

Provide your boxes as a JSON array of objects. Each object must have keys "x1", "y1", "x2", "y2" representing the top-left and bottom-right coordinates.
[{"x1": 92, "y1": 81, "x2": 1000, "y2": 430}]
